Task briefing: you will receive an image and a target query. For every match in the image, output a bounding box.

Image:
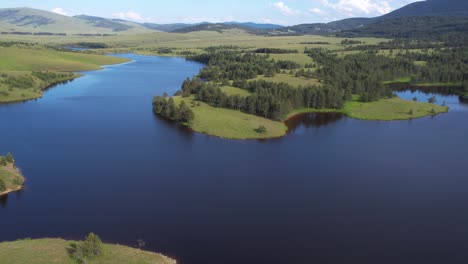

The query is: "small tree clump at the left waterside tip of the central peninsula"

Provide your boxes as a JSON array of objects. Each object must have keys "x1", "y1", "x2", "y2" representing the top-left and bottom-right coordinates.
[{"x1": 153, "y1": 96, "x2": 195, "y2": 123}]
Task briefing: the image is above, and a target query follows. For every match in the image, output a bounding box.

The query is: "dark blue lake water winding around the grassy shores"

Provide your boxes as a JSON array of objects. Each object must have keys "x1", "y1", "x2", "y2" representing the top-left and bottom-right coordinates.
[{"x1": 0, "y1": 55, "x2": 468, "y2": 264}]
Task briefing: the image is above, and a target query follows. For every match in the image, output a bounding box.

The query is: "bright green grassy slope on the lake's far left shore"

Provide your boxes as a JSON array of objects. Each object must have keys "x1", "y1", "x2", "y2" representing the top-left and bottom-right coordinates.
[{"x1": 0, "y1": 42, "x2": 127, "y2": 103}]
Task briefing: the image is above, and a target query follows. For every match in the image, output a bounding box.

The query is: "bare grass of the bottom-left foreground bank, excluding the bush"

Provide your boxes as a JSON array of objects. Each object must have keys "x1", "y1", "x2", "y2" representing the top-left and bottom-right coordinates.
[{"x1": 0, "y1": 239, "x2": 176, "y2": 264}]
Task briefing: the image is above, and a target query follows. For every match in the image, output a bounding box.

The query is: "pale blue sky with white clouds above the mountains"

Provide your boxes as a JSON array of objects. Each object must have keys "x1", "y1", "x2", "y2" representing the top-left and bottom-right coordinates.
[{"x1": 0, "y1": 0, "x2": 416, "y2": 25}]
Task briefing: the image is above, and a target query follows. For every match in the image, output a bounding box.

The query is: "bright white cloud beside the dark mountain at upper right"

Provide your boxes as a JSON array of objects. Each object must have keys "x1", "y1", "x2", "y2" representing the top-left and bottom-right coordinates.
[{"x1": 322, "y1": 0, "x2": 392, "y2": 16}]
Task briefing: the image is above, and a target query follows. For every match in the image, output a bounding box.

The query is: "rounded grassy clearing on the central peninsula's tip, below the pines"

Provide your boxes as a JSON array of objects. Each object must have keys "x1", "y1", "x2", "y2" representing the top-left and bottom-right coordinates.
[{"x1": 174, "y1": 97, "x2": 287, "y2": 139}]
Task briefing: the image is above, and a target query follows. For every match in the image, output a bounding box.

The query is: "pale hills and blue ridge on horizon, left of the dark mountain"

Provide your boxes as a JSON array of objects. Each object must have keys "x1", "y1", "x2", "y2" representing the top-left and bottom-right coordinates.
[{"x1": 0, "y1": 8, "x2": 282, "y2": 35}]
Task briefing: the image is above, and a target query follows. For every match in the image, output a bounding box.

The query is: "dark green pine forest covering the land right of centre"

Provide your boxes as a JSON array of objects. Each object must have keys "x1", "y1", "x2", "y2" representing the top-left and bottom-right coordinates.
[{"x1": 155, "y1": 43, "x2": 468, "y2": 120}]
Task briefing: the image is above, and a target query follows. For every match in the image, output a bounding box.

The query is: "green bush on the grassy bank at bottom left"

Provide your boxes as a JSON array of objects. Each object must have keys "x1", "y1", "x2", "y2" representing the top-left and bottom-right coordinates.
[{"x1": 67, "y1": 233, "x2": 103, "y2": 263}]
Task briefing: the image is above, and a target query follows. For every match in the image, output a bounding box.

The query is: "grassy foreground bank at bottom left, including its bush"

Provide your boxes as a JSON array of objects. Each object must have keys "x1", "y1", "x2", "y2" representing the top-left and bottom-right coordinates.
[{"x1": 0, "y1": 234, "x2": 176, "y2": 264}]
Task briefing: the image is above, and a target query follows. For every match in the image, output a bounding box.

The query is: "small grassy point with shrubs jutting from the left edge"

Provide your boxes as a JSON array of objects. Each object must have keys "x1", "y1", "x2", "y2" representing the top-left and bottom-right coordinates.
[{"x1": 0, "y1": 153, "x2": 25, "y2": 196}]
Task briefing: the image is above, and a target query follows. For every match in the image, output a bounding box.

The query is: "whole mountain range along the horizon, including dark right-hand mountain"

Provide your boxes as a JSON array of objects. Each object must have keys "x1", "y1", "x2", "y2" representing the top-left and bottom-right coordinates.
[{"x1": 0, "y1": 0, "x2": 468, "y2": 36}]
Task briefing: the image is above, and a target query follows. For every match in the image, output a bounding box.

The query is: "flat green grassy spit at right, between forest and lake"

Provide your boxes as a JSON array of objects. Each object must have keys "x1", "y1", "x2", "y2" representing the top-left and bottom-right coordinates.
[{"x1": 343, "y1": 98, "x2": 449, "y2": 121}]
